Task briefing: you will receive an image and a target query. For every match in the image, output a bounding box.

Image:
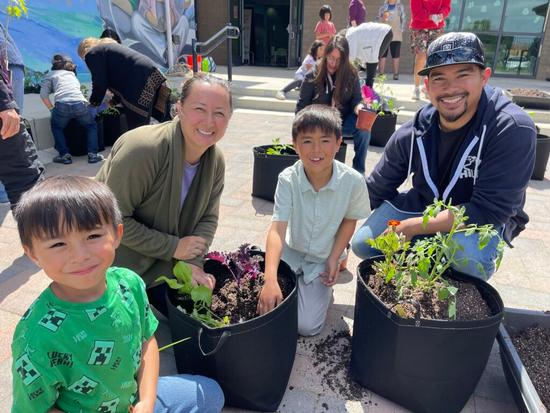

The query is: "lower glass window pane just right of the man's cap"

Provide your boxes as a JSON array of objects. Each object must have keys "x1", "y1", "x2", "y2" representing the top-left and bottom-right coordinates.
[{"x1": 495, "y1": 36, "x2": 541, "y2": 76}]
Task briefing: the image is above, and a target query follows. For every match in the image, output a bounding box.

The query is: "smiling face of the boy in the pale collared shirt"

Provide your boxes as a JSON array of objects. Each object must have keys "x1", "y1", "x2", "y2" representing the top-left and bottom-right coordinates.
[{"x1": 294, "y1": 128, "x2": 342, "y2": 179}]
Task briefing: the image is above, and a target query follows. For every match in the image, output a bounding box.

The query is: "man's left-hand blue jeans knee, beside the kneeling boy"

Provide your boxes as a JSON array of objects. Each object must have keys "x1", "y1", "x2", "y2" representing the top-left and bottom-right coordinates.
[{"x1": 351, "y1": 202, "x2": 422, "y2": 259}]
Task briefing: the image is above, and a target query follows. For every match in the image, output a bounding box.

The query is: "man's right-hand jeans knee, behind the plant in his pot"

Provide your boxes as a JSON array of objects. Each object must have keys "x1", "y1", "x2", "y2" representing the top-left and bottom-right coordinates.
[{"x1": 453, "y1": 229, "x2": 502, "y2": 280}]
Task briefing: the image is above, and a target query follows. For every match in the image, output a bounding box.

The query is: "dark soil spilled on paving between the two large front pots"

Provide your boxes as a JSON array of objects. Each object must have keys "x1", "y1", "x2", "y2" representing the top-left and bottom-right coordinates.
[{"x1": 300, "y1": 324, "x2": 370, "y2": 403}]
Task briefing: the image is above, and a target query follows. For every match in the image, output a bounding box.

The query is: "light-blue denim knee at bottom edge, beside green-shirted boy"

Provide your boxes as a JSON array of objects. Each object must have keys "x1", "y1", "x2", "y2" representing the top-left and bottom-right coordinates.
[{"x1": 154, "y1": 374, "x2": 225, "y2": 413}]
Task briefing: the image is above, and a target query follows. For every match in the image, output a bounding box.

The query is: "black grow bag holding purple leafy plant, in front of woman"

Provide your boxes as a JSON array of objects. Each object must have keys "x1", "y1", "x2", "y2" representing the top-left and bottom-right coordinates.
[{"x1": 167, "y1": 253, "x2": 298, "y2": 412}]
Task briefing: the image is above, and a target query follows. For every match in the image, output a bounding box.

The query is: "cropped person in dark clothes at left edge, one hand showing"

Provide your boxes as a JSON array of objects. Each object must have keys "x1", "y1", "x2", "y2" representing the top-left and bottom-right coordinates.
[{"x1": 0, "y1": 72, "x2": 44, "y2": 209}]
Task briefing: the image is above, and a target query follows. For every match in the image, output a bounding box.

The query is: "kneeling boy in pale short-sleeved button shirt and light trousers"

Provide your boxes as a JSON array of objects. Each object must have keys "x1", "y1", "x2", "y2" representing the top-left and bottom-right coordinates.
[{"x1": 258, "y1": 105, "x2": 370, "y2": 336}]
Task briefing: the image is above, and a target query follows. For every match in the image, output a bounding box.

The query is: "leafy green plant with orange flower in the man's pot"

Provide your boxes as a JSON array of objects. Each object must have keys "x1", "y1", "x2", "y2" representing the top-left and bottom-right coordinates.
[{"x1": 367, "y1": 201, "x2": 504, "y2": 319}]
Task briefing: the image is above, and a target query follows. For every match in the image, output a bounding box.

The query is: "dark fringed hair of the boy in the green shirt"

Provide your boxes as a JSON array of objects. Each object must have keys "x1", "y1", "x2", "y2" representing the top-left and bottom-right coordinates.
[{"x1": 14, "y1": 176, "x2": 122, "y2": 248}]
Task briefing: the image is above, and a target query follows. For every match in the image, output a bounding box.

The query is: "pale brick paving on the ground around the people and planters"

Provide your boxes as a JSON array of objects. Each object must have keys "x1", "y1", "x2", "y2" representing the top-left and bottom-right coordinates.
[{"x1": 0, "y1": 76, "x2": 550, "y2": 413}]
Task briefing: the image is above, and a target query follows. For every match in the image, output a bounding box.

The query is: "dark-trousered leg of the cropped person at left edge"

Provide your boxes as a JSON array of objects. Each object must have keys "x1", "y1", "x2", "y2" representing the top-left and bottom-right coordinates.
[{"x1": 0, "y1": 122, "x2": 44, "y2": 209}]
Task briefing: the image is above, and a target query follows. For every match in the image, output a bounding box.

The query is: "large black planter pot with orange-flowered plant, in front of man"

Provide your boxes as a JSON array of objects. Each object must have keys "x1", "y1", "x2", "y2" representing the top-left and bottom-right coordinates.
[{"x1": 350, "y1": 259, "x2": 503, "y2": 413}]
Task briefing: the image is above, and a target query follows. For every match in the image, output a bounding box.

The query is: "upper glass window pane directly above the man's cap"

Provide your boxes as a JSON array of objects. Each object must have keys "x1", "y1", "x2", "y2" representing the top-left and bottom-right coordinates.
[{"x1": 462, "y1": 0, "x2": 506, "y2": 32}]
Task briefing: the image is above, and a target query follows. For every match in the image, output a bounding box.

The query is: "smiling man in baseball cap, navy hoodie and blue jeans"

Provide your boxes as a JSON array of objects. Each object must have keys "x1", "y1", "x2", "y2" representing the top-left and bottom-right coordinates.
[{"x1": 352, "y1": 33, "x2": 536, "y2": 279}]
